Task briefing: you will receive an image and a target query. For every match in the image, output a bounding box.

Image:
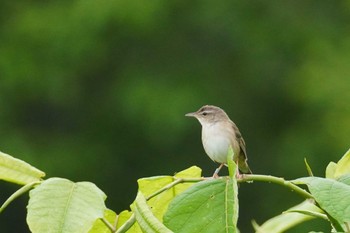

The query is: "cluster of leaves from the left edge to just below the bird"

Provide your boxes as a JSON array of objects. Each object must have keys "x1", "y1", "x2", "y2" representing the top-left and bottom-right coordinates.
[{"x1": 0, "y1": 148, "x2": 238, "y2": 233}]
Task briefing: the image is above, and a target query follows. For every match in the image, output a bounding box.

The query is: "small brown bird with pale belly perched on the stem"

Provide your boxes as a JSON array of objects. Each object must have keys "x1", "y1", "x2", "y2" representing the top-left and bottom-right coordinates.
[{"x1": 185, "y1": 105, "x2": 252, "y2": 177}]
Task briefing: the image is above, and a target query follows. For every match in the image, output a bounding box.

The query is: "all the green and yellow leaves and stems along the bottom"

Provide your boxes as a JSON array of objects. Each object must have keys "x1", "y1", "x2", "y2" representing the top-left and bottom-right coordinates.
[{"x1": 0, "y1": 150, "x2": 350, "y2": 233}]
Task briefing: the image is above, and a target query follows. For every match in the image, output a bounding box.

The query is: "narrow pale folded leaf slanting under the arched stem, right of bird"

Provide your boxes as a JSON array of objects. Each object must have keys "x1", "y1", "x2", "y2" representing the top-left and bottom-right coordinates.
[{"x1": 252, "y1": 200, "x2": 323, "y2": 233}]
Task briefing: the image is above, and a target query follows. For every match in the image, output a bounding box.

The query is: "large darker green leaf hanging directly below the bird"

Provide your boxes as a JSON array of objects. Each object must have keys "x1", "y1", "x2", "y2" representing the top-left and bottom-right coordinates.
[{"x1": 163, "y1": 177, "x2": 238, "y2": 233}]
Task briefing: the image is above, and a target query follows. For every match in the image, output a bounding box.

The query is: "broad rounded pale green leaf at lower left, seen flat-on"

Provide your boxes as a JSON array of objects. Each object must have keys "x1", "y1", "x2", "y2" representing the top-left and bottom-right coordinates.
[{"x1": 27, "y1": 178, "x2": 106, "y2": 233}]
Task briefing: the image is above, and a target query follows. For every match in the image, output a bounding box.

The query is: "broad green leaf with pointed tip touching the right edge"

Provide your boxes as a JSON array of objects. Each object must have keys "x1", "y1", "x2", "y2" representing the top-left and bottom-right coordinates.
[{"x1": 293, "y1": 177, "x2": 350, "y2": 223}]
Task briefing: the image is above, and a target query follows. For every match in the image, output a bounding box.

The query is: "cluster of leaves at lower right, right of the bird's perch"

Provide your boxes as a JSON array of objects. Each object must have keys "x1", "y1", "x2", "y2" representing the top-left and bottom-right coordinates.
[{"x1": 253, "y1": 150, "x2": 350, "y2": 233}]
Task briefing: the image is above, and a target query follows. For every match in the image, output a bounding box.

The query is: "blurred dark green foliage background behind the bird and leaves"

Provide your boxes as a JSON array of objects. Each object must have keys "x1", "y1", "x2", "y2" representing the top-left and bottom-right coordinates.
[{"x1": 0, "y1": 0, "x2": 350, "y2": 233}]
